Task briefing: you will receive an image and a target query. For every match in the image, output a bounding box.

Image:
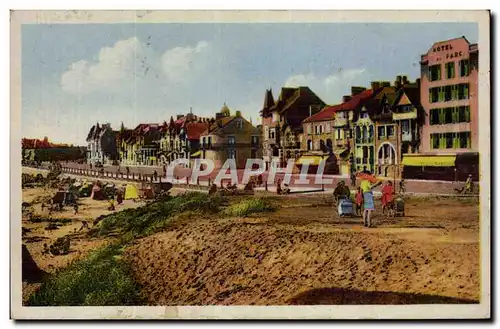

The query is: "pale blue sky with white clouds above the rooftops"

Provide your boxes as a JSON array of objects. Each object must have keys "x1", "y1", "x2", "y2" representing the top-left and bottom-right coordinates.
[{"x1": 21, "y1": 23, "x2": 478, "y2": 144}]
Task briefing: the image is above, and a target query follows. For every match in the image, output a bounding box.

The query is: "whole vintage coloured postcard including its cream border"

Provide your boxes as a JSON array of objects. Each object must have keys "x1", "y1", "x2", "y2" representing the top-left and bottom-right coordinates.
[{"x1": 11, "y1": 10, "x2": 491, "y2": 319}]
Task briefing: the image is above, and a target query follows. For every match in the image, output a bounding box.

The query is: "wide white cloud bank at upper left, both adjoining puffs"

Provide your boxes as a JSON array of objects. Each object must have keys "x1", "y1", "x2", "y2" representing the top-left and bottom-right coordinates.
[{"x1": 61, "y1": 37, "x2": 208, "y2": 95}]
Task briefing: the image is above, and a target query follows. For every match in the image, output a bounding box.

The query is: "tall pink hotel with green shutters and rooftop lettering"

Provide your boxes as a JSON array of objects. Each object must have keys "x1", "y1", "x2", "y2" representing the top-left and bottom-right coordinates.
[{"x1": 420, "y1": 37, "x2": 478, "y2": 155}]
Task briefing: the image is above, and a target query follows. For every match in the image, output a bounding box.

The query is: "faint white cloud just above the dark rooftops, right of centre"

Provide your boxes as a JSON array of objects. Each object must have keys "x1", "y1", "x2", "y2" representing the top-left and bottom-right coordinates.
[{"x1": 284, "y1": 68, "x2": 370, "y2": 104}]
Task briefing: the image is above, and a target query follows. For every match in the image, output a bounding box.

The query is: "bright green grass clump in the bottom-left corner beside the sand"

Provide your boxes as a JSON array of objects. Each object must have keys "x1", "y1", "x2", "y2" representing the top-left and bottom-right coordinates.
[{"x1": 28, "y1": 244, "x2": 139, "y2": 306}]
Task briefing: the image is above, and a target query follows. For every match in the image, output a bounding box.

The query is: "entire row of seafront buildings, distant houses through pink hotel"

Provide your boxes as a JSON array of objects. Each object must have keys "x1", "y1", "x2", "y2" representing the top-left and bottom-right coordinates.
[{"x1": 75, "y1": 37, "x2": 478, "y2": 179}]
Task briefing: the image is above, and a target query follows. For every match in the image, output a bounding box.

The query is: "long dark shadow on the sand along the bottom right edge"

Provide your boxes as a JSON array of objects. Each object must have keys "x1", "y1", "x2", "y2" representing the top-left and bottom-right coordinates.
[{"x1": 288, "y1": 288, "x2": 479, "y2": 305}]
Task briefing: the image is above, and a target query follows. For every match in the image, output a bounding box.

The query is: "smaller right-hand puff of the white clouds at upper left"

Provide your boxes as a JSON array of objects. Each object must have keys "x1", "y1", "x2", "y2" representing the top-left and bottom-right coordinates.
[{"x1": 162, "y1": 41, "x2": 208, "y2": 82}]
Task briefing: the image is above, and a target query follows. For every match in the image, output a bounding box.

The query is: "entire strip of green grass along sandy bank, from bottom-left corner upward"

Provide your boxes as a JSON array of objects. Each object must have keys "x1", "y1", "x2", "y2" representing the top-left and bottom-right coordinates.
[{"x1": 28, "y1": 192, "x2": 275, "y2": 306}]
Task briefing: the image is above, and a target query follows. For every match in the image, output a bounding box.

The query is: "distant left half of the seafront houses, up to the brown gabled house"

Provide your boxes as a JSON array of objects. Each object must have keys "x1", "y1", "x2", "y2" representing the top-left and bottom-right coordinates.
[{"x1": 87, "y1": 104, "x2": 261, "y2": 168}]
